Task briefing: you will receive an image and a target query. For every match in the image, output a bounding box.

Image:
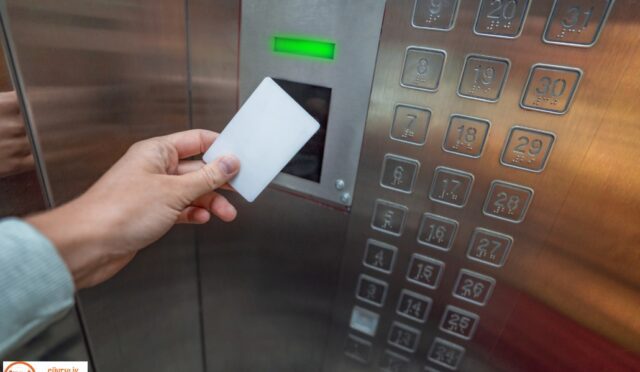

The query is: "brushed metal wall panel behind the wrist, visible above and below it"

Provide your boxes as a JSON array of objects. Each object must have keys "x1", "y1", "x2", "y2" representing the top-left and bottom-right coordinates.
[{"x1": 6, "y1": 0, "x2": 203, "y2": 371}]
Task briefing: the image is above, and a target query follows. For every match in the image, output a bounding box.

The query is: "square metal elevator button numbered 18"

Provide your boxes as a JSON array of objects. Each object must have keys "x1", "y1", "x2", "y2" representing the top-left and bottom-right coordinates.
[{"x1": 442, "y1": 115, "x2": 491, "y2": 158}]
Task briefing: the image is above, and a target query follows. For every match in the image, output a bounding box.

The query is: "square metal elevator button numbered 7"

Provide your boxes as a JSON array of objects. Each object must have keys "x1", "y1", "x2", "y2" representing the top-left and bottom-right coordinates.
[{"x1": 391, "y1": 105, "x2": 431, "y2": 145}]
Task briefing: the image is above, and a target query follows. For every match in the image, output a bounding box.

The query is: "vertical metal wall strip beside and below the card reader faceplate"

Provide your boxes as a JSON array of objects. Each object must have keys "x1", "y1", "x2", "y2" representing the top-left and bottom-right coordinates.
[{"x1": 190, "y1": 0, "x2": 358, "y2": 371}]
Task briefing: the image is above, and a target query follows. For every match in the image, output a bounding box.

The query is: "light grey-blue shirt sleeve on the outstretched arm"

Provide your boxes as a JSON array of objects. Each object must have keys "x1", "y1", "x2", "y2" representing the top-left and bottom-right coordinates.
[{"x1": 0, "y1": 218, "x2": 74, "y2": 359}]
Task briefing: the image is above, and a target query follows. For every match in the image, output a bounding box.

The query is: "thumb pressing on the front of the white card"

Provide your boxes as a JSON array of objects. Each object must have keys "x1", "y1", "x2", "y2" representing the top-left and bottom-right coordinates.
[{"x1": 180, "y1": 155, "x2": 240, "y2": 201}]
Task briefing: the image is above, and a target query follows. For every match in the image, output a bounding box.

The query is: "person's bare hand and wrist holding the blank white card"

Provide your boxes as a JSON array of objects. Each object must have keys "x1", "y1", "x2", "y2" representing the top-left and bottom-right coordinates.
[{"x1": 27, "y1": 130, "x2": 240, "y2": 288}]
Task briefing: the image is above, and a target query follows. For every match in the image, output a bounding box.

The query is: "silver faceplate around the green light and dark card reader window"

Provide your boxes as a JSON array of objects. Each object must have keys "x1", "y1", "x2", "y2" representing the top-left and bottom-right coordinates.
[{"x1": 240, "y1": 0, "x2": 385, "y2": 207}]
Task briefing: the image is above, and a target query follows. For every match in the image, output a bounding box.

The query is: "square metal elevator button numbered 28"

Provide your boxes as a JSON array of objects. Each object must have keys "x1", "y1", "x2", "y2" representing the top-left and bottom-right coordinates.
[{"x1": 482, "y1": 181, "x2": 533, "y2": 223}]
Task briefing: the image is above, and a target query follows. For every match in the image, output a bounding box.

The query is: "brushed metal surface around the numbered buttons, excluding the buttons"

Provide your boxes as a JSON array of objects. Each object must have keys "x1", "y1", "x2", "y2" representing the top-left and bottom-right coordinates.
[{"x1": 325, "y1": 0, "x2": 640, "y2": 371}]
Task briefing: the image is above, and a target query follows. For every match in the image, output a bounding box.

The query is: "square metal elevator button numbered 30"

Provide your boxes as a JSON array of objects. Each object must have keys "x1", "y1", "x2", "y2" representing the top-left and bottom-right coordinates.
[{"x1": 520, "y1": 64, "x2": 582, "y2": 115}]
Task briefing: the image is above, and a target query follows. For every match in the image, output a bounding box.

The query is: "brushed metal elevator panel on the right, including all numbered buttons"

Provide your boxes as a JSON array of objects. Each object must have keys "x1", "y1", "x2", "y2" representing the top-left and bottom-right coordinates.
[{"x1": 325, "y1": 0, "x2": 640, "y2": 371}]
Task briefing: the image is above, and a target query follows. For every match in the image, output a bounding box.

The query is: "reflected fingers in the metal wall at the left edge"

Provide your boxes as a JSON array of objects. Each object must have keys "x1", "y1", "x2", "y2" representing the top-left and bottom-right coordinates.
[{"x1": 0, "y1": 92, "x2": 34, "y2": 177}]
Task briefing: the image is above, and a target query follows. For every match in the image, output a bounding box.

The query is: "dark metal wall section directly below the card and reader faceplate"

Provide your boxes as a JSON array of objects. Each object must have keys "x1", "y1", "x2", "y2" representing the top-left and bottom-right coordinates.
[{"x1": 198, "y1": 189, "x2": 348, "y2": 371}]
